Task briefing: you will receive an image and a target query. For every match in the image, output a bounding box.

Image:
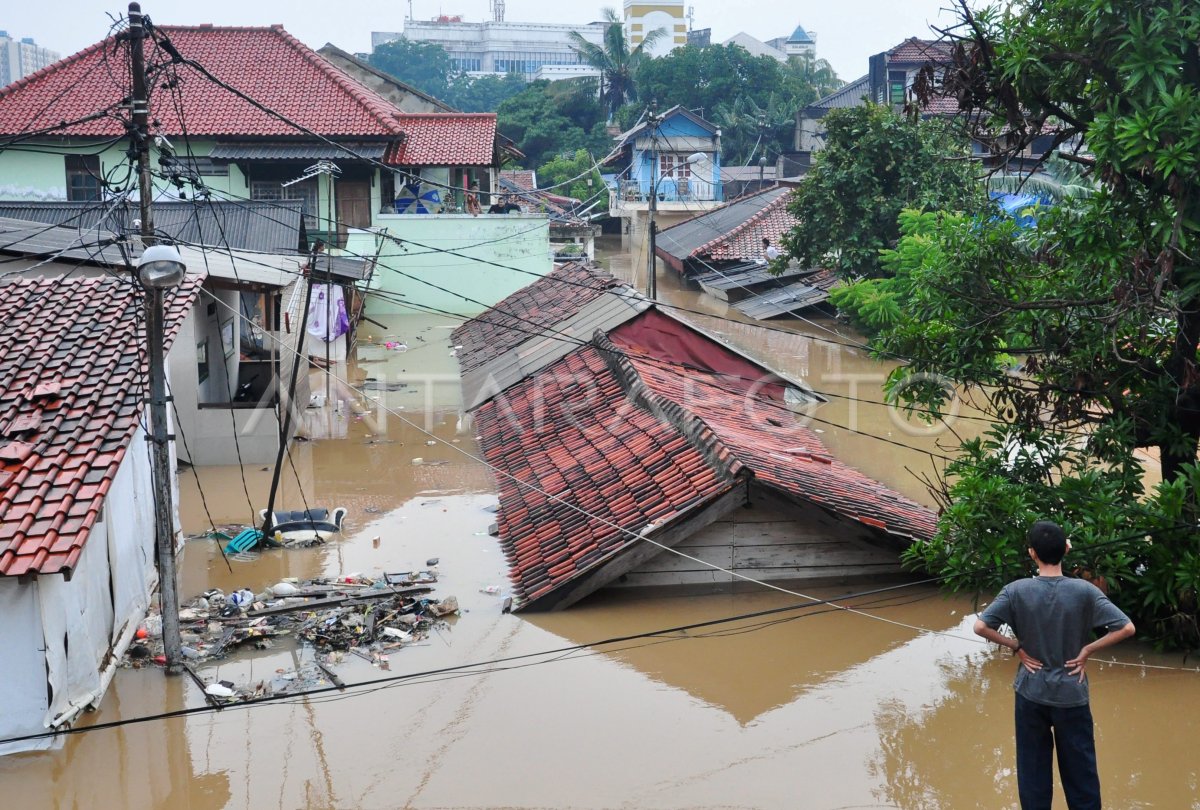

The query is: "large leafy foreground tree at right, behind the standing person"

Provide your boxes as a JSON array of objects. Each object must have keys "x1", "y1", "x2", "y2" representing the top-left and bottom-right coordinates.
[{"x1": 854, "y1": 0, "x2": 1200, "y2": 647}]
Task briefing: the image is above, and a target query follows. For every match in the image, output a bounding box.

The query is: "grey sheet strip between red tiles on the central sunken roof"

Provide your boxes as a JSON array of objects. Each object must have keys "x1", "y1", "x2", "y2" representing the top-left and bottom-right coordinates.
[{"x1": 462, "y1": 288, "x2": 650, "y2": 410}]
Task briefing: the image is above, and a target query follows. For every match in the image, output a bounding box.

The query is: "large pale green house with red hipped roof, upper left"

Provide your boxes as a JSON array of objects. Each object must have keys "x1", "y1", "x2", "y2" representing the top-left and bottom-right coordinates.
[{"x1": 0, "y1": 25, "x2": 552, "y2": 313}]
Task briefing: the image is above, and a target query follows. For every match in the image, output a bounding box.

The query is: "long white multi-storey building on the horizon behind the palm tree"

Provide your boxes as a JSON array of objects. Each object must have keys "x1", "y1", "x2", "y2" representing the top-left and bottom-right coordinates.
[{"x1": 371, "y1": 14, "x2": 607, "y2": 80}]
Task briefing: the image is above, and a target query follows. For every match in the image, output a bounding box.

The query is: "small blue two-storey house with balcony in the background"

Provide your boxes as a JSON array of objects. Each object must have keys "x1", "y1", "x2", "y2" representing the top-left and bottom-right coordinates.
[{"x1": 608, "y1": 106, "x2": 725, "y2": 246}]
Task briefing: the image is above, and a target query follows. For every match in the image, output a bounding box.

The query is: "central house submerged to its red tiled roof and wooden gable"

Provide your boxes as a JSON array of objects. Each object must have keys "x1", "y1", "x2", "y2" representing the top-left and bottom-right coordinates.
[{"x1": 454, "y1": 265, "x2": 935, "y2": 611}]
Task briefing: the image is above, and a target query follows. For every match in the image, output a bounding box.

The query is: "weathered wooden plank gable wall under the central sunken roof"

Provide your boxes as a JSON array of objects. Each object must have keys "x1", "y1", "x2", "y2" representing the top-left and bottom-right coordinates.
[{"x1": 611, "y1": 486, "x2": 902, "y2": 592}]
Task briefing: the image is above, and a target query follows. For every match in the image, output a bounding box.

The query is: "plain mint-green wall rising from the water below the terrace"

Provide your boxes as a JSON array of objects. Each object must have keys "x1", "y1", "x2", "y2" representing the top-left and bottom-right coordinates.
[{"x1": 364, "y1": 214, "x2": 553, "y2": 318}]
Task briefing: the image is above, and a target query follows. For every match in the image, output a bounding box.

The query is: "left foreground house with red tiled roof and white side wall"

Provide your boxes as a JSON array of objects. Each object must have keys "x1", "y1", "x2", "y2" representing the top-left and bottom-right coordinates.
[{"x1": 0, "y1": 276, "x2": 200, "y2": 754}]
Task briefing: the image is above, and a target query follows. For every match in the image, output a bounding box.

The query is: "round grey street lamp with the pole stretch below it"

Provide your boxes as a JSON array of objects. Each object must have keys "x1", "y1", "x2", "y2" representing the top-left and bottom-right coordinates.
[{"x1": 138, "y1": 245, "x2": 186, "y2": 674}]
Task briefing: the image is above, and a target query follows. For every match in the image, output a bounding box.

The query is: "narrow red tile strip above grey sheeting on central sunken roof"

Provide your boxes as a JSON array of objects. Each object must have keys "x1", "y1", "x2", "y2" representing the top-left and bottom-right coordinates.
[{"x1": 452, "y1": 263, "x2": 622, "y2": 372}]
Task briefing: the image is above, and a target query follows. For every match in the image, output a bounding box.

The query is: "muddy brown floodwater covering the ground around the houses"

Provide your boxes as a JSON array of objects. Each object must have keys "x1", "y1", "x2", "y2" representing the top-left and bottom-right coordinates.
[{"x1": 0, "y1": 242, "x2": 1200, "y2": 810}]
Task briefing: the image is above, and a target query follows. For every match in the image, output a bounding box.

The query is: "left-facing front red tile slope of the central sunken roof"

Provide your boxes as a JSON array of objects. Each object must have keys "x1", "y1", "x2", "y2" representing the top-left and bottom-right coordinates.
[{"x1": 475, "y1": 347, "x2": 742, "y2": 606}]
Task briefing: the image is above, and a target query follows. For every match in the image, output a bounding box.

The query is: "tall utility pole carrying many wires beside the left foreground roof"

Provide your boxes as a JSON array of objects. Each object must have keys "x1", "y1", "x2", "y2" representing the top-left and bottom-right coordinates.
[{"x1": 127, "y1": 2, "x2": 184, "y2": 674}]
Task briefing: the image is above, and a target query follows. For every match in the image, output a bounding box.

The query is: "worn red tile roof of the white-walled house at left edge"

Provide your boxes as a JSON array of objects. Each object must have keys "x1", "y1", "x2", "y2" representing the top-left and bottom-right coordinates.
[{"x1": 0, "y1": 276, "x2": 203, "y2": 576}]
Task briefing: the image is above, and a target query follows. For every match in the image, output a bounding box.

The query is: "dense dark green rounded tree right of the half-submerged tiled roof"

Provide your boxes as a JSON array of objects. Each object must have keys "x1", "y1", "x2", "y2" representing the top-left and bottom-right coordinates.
[{"x1": 782, "y1": 104, "x2": 985, "y2": 277}]
